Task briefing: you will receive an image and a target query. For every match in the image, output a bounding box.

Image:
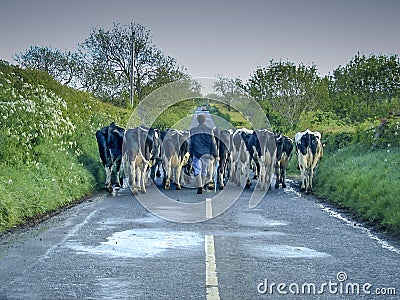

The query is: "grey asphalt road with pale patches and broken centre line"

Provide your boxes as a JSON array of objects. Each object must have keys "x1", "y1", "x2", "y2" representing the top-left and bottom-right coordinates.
[{"x1": 0, "y1": 175, "x2": 400, "y2": 299}]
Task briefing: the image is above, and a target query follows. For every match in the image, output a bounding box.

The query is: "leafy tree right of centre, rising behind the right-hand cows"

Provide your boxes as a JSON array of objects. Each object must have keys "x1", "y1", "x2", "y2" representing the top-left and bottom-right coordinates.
[{"x1": 244, "y1": 61, "x2": 327, "y2": 130}]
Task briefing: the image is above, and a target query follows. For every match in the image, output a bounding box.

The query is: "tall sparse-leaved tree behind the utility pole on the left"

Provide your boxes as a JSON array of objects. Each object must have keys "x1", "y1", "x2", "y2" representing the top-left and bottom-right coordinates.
[{"x1": 79, "y1": 23, "x2": 187, "y2": 105}]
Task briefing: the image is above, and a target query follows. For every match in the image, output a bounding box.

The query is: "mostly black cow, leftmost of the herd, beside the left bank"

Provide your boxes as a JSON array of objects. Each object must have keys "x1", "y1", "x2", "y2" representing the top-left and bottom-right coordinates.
[{"x1": 96, "y1": 122, "x2": 124, "y2": 193}]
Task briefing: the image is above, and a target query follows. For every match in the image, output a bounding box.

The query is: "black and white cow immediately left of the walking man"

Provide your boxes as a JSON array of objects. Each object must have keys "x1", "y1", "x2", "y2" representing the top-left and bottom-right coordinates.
[{"x1": 161, "y1": 129, "x2": 190, "y2": 190}]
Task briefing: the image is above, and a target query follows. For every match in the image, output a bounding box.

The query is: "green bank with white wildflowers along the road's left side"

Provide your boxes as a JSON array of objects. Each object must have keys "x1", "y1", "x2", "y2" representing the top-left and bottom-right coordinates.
[{"x1": 0, "y1": 62, "x2": 130, "y2": 233}]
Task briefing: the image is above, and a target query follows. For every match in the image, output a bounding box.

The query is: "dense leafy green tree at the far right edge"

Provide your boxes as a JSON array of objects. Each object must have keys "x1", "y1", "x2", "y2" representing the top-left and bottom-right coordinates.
[{"x1": 329, "y1": 53, "x2": 400, "y2": 122}]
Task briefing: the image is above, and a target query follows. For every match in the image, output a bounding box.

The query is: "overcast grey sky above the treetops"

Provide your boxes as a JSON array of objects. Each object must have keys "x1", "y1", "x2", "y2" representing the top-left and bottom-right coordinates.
[{"x1": 0, "y1": 0, "x2": 400, "y2": 80}]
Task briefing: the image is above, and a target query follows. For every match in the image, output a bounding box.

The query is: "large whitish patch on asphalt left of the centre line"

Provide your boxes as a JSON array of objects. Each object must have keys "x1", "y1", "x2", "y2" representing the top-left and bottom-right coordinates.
[{"x1": 67, "y1": 229, "x2": 203, "y2": 258}]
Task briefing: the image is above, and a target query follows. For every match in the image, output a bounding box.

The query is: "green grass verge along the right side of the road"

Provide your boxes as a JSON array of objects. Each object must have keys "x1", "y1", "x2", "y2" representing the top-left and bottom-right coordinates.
[{"x1": 314, "y1": 144, "x2": 400, "y2": 236}]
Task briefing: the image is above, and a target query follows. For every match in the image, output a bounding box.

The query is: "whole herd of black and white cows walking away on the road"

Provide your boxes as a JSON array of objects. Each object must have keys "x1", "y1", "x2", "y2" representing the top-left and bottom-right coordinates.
[{"x1": 96, "y1": 123, "x2": 323, "y2": 194}]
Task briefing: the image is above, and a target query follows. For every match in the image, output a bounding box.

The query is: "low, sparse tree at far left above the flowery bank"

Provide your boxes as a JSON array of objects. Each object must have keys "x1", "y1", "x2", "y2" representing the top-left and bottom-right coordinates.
[{"x1": 13, "y1": 46, "x2": 82, "y2": 87}]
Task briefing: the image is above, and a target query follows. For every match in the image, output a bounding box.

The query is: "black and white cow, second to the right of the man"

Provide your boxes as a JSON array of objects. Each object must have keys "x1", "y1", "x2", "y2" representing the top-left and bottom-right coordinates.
[{"x1": 231, "y1": 128, "x2": 253, "y2": 188}]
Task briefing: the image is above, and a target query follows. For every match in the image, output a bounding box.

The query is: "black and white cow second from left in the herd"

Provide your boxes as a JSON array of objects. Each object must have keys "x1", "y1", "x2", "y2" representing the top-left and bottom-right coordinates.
[{"x1": 123, "y1": 126, "x2": 160, "y2": 194}]
